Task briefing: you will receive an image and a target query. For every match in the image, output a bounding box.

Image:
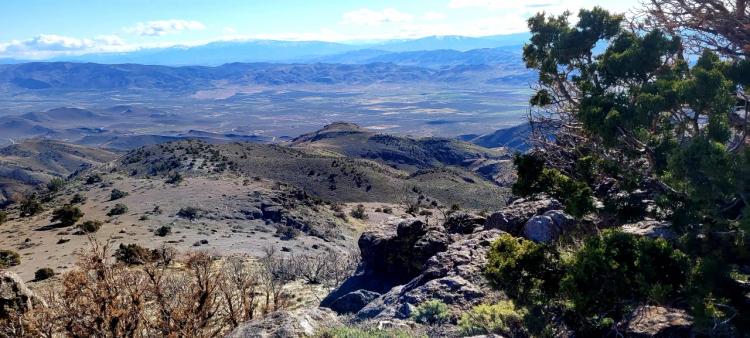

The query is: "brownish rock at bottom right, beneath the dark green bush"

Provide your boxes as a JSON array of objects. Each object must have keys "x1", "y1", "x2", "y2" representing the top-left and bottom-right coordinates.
[{"x1": 622, "y1": 305, "x2": 693, "y2": 337}]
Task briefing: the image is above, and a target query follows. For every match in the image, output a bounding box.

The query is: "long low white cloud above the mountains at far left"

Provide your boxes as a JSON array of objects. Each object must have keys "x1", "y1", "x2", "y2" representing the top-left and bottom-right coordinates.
[{"x1": 0, "y1": 34, "x2": 132, "y2": 59}]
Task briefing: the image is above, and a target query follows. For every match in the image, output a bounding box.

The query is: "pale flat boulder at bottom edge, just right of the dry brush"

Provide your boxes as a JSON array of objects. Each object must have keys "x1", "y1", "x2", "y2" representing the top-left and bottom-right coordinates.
[{"x1": 228, "y1": 308, "x2": 342, "y2": 338}]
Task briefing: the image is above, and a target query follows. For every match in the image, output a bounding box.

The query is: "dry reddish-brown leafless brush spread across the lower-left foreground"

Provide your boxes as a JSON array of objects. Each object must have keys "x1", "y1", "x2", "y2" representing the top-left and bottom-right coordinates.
[{"x1": 0, "y1": 238, "x2": 356, "y2": 337}]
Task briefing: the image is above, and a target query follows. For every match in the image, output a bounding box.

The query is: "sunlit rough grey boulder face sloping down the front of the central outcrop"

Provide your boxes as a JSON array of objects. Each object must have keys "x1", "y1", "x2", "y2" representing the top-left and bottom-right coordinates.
[{"x1": 357, "y1": 230, "x2": 502, "y2": 319}]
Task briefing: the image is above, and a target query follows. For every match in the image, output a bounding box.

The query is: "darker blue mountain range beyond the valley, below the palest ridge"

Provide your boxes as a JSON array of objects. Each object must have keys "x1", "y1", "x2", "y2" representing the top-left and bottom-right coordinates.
[{"x1": 0, "y1": 54, "x2": 533, "y2": 91}]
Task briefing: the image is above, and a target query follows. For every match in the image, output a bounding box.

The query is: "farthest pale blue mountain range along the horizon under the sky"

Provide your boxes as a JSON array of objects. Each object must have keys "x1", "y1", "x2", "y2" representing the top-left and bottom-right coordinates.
[{"x1": 0, "y1": 33, "x2": 530, "y2": 66}]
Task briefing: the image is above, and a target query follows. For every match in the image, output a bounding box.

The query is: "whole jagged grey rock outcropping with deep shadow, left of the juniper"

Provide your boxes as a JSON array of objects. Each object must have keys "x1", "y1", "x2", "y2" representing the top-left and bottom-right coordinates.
[{"x1": 321, "y1": 198, "x2": 575, "y2": 320}]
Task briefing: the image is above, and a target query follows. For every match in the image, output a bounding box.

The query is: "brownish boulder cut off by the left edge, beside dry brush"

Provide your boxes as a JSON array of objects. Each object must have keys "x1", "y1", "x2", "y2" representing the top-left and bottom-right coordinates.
[{"x1": 0, "y1": 271, "x2": 44, "y2": 318}]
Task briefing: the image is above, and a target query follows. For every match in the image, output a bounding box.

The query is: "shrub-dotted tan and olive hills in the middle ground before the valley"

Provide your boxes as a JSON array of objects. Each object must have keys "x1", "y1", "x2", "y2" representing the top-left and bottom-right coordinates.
[{"x1": 0, "y1": 129, "x2": 508, "y2": 278}]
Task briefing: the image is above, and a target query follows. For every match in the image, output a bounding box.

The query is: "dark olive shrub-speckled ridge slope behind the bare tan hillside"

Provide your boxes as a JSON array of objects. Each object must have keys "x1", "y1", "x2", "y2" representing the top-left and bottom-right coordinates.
[{"x1": 117, "y1": 140, "x2": 506, "y2": 209}]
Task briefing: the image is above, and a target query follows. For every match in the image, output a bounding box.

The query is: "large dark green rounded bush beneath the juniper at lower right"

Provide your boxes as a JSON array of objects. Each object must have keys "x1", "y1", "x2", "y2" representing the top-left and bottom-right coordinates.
[{"x1": 561, "y1": 231, "x2": 690, "y2": 325}]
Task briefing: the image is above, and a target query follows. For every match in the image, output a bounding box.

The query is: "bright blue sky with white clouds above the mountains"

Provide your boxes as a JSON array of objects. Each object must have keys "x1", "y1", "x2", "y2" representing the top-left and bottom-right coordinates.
[{"x1": 0, "y1": 0, "x2": 638, "y2": 59}]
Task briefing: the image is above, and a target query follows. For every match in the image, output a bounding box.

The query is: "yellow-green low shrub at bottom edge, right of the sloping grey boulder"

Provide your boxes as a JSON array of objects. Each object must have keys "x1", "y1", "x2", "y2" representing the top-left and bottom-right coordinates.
[{"x1": 458, "y1": 300, "x2": 526, "y2": 337}]
